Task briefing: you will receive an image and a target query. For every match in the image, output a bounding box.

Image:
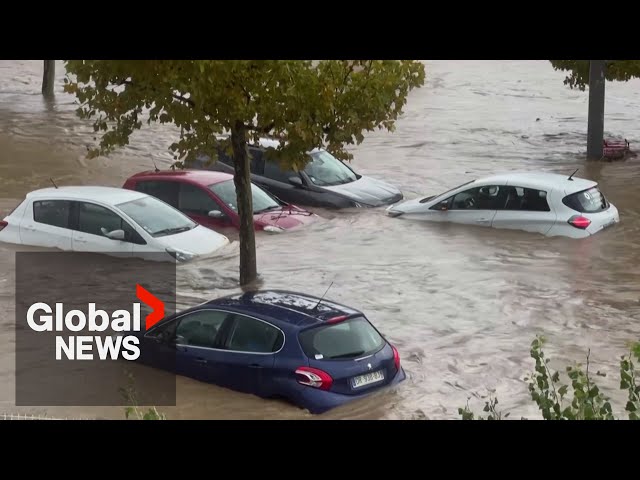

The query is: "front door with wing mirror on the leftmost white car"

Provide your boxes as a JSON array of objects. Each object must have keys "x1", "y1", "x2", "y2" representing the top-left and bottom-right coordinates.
[{"x1": 71, "y1": 201, "x2": 133, "y2": 257}]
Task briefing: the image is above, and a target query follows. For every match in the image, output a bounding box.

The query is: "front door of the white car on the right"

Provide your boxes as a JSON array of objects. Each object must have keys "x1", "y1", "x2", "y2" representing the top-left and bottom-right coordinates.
[{"x1": 434, "y1": 185, "x2": 504, "y2": 227}]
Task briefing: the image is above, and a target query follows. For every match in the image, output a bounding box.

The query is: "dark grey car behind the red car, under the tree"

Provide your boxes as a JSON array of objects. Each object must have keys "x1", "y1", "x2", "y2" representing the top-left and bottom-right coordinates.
[{"x1": 191, "y1": 139, "x2": 403, "y2": 209}]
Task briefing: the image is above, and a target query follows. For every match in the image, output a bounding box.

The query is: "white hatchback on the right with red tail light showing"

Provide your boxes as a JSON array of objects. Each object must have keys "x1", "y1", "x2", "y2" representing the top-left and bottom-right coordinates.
[{"x1": 386, "y1": 172, "x2": 620, "y2": 238}]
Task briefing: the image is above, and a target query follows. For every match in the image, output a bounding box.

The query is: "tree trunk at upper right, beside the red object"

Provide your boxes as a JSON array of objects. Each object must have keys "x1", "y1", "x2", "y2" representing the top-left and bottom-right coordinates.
[{"x1": 587, "y1": 60, "x2": 606, "y2": 160}]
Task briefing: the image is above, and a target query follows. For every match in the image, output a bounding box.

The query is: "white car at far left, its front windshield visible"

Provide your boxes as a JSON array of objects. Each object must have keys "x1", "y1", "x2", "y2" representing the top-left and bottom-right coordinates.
[{"x1": 0, "y1": 186, "x2": 229, "y2": 262}]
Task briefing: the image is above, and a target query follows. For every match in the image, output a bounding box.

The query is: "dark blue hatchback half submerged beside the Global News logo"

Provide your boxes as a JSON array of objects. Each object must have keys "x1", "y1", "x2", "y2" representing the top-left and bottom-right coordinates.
[{"x1": 136, "y1": 290, "x2": 406, "y2": 413}]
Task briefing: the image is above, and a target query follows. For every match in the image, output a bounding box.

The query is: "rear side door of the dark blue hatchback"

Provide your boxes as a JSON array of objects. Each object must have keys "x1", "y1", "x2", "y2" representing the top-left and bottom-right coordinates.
[{"x1": 214, "y1": 314, "x2": 284, "y2": 396}]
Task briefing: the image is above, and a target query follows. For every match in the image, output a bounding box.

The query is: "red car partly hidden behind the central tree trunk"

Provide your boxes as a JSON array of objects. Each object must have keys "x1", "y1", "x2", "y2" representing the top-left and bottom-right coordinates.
[{"x1": 123, "y1": 170, "x2": 318, "y2": 232}]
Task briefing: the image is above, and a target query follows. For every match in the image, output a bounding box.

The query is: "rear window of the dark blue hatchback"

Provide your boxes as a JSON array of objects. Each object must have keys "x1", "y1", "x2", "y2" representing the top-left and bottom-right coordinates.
[{"x1": 299, "y1": 317, "x2": 385, "y2": 360}]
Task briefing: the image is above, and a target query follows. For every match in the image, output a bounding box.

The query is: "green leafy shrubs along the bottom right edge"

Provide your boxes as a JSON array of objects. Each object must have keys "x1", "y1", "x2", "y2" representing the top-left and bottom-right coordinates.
[{"x1": 458, "y1": 337, "x2": 640, "y2": 420}]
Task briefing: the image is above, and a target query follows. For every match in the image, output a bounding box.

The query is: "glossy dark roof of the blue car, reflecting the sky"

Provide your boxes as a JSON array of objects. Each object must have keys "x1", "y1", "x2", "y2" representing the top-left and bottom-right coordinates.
[{"x1": 200, "y1": 290, "x2": 362, "y2": 328}]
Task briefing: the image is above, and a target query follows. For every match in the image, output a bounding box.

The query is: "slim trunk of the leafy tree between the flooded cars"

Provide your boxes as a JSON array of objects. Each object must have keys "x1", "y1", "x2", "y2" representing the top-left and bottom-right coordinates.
[{"x1": 231, "y1": 122, "x2": 258, "y2": 285}]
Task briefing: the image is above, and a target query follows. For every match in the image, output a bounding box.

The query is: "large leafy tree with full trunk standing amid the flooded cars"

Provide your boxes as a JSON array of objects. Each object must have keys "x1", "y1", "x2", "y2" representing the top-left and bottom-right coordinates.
[{"x1": 65, "y1": 60, "x2": 425, "y2": 285}]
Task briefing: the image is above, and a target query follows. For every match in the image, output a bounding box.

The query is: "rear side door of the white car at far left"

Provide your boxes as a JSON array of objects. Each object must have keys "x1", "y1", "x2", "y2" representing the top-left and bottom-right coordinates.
[{"x1": 20, "y1": 200, "x2": 73, "y2": 251}]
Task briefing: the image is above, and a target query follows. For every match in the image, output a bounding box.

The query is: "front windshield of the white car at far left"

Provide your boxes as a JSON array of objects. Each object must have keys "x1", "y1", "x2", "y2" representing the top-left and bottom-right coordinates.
[{"x1": 116, "y1": 196, "x2": 198, "y2": 237}]
